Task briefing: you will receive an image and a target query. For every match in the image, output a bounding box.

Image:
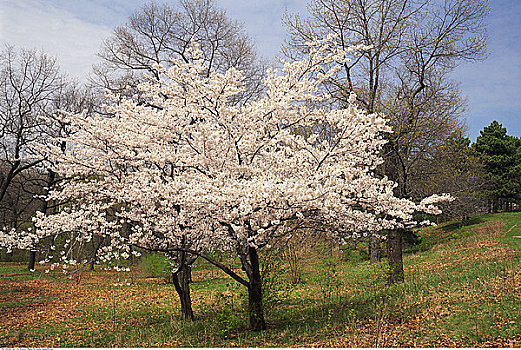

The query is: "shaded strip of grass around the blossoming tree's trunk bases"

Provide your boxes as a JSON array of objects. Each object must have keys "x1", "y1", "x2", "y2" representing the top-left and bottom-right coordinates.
[{"x1": 75, "y1": 284, "x2": 386, "y2": 347}]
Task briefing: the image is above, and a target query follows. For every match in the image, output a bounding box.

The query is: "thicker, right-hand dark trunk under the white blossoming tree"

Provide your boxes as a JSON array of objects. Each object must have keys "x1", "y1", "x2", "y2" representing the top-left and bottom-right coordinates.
[{"x1": 247, "y1": 247, "x2": 266, "y2": 331}]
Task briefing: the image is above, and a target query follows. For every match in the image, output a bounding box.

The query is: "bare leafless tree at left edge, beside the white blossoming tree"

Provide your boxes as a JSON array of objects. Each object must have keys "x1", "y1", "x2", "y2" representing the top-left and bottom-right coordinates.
[{"x1": 0, "y1": 46, "x2": 93, "y2": 270}]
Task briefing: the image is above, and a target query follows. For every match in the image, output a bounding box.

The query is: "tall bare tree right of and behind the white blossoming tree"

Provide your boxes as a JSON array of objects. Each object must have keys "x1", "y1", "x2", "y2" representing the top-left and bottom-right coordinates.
[{"x1": 283, "y1": 0, "x2": 488, "y2": 282}]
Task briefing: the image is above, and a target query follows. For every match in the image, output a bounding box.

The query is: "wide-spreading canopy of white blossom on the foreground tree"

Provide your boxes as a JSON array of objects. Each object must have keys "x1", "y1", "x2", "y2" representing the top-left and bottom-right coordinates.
[{"x1": 0, "y1": 38, "x2": 450, "y2": 271}]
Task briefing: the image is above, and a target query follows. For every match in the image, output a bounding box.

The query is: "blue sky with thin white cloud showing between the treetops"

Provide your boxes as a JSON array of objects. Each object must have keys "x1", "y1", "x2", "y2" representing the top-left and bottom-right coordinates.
[{"x1": 0, "y1": 0, "x2": 521, "y2": 141}]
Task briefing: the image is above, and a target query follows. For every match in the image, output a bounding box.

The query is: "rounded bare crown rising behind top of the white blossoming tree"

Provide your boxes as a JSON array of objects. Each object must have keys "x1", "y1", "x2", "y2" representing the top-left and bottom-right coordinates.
[{"x1": 90, "y1": 0, "x2": 264, "y2": 103}]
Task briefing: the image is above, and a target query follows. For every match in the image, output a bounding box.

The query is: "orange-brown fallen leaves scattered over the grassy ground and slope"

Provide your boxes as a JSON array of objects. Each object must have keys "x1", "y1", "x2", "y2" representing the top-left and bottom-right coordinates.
[{"x1": 0, "y1": 222, "x2": 521, "y2": 347}]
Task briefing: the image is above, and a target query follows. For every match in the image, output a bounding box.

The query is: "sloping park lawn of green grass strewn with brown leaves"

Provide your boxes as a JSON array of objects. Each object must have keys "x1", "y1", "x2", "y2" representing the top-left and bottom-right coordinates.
[{"x1": 0, "y1": 213, "x2": 521, "y2": 347}]
